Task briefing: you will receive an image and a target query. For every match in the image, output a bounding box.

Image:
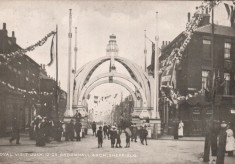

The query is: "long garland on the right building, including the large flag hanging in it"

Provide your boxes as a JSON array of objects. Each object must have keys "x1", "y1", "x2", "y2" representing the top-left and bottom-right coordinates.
[{"x1": 159, "y1": 0, "x2": 221, "y2": 104}]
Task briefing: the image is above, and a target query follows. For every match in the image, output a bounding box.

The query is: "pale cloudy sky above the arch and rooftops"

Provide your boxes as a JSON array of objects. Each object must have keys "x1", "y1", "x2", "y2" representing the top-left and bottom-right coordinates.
[{"x1": 0, "y1": 0, "x2": 231, "y2": 104}]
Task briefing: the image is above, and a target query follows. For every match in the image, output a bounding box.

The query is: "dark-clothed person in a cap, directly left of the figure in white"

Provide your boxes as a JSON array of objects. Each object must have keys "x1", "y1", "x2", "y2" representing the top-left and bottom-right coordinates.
[{"x1": 216, "y1": 121, "x2": 227, "y2": 164}]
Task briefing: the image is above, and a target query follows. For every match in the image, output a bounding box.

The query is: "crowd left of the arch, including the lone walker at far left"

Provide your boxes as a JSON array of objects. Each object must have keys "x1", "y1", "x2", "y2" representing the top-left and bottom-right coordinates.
[{"x1": 9, "y1": 115, "x2": 82, "y2": 146}]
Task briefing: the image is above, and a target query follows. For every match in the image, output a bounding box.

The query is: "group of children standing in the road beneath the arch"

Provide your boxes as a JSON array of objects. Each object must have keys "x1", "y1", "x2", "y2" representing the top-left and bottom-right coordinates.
[{"x1": 92, "y1": 122, "x2": 148, "y2": 148}]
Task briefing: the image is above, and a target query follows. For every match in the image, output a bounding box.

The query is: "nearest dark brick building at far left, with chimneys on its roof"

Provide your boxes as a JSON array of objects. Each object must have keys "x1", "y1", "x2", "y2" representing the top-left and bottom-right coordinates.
[{"x1": 0, "y1": 23, "x2": 40, "y2": 133}]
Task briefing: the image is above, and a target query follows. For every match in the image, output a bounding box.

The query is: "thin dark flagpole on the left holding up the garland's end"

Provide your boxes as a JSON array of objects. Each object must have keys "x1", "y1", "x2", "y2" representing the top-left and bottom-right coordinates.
[{"x1": 55, "y1": 25, "x2": 59, "y2": 119}]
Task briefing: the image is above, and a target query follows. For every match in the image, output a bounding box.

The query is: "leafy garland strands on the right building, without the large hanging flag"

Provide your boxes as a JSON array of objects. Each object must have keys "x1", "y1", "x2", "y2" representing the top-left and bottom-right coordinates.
[{"x1": 159, "y1": 0, "x2": 221, "y2": 105}]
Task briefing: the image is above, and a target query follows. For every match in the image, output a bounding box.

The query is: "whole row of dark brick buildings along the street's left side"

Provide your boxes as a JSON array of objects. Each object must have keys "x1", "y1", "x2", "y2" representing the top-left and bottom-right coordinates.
[{"x1": 0, "y1": 23, "x2": 66, "y2": 135}]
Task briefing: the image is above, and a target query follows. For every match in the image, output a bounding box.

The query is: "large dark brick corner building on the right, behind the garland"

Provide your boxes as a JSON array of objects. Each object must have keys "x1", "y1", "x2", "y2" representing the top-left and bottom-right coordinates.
[{"x1": 160, "y1": 13, "x2": 235, "y2": 136}]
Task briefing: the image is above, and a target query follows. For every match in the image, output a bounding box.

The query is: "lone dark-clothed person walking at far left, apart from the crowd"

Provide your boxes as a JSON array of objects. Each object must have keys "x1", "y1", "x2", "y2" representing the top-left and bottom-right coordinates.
[{"x1": 9, "y1": 117, "x2": 20, "y2": 145}]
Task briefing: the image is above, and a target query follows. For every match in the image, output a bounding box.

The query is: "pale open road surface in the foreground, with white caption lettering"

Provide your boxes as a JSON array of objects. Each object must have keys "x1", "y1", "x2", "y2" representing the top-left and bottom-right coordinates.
[{"x1": 0, "y1": 130, "x2": 235, "y2": 164}]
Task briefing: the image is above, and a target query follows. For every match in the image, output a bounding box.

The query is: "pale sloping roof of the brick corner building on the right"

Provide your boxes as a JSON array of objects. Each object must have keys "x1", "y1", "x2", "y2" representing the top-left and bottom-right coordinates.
[{"x1": 195, "y1": 24, "x2": 235, "y2": 37}]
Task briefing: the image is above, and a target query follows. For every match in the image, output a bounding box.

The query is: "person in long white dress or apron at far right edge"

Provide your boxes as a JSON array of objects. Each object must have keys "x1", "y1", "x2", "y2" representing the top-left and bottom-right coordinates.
[{"x1": 226, "y1": 123, "x2": 235, "y2": 156}]
